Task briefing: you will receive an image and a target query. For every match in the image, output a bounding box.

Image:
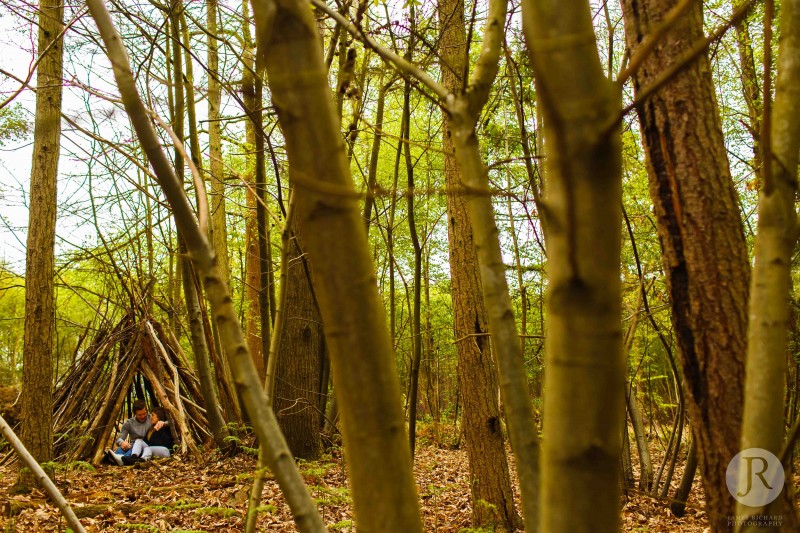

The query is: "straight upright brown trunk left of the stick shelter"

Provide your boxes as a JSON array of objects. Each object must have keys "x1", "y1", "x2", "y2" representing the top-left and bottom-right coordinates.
[{"x1": 21, "y1": 0, "x2": 64, "y2": 470}]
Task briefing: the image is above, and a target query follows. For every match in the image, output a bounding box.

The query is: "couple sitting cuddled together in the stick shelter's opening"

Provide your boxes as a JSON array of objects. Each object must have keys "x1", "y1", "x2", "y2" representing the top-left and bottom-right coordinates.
[{"x1": 106, "y1": 400, "x2": 173, "y2": 466}]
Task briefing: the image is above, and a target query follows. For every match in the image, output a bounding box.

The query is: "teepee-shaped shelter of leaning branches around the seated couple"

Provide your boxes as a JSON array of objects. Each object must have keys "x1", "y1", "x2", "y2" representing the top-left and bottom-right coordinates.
[{"x1": 53, "y1": 312, "x2": 216, "y2": 463}]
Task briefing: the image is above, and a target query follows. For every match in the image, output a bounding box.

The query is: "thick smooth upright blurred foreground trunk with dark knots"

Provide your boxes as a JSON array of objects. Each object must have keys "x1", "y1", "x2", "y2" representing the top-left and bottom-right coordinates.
[{"x1": 523, "y1": 0, "x2": 625, "y2": 533}]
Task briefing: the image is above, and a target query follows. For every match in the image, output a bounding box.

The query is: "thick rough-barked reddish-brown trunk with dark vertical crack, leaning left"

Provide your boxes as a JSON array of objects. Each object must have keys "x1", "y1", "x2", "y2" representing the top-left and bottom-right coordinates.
[{"x1": 623, "y1": 0, "x2": 750, "y2": 531}]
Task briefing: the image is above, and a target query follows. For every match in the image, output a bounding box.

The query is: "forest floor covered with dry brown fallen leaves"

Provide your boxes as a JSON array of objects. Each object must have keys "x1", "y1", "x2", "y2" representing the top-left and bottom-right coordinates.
[{"x1": 0, "y1": 428, "x2": 788, "y2": 533}]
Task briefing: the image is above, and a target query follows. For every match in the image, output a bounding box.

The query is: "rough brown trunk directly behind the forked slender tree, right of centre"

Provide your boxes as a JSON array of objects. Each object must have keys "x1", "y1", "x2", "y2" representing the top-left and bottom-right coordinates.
[{"x1": 438, "y1": 0, "x2": 518, "y2": 530}]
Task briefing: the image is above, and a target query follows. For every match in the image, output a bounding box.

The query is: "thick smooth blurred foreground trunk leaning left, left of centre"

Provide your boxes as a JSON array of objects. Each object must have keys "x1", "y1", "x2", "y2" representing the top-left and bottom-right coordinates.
[{"x1": 253, "y1": 0, "x2": 422, "y2": 533}]
